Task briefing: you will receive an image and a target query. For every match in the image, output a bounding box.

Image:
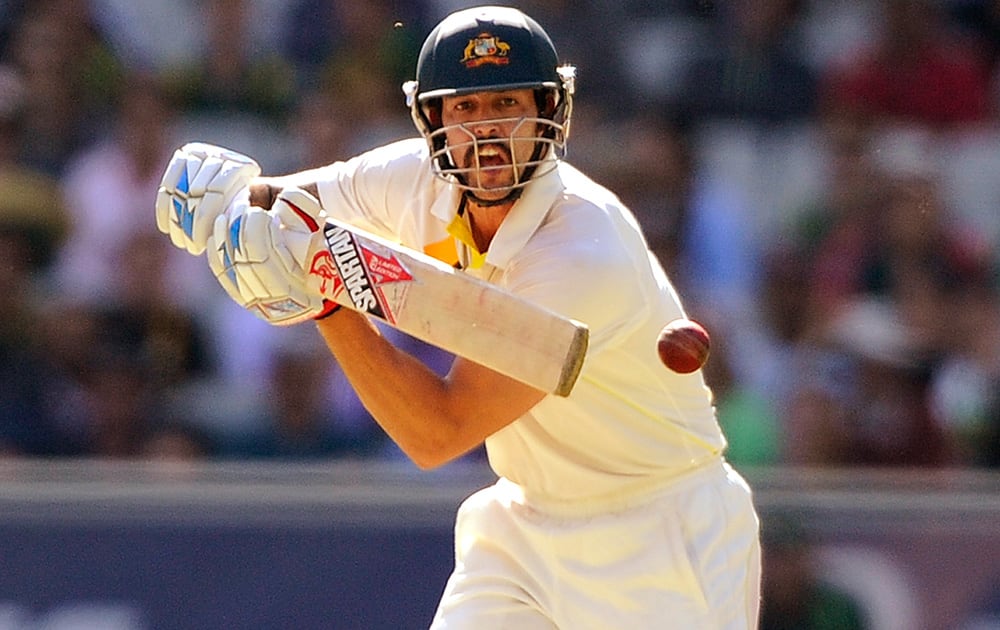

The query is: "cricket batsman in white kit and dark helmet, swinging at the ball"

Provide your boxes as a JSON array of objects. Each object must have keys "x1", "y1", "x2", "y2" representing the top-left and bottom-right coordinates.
[{"x1": 156, "y1": 6, "x2": 760, "y2": 630}]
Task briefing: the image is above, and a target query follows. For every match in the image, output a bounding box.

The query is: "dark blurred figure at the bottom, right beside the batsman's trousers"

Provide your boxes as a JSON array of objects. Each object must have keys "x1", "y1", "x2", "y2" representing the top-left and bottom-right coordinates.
[{"x1": 760, "y1": 514, "x2": 871, "y2": 630}]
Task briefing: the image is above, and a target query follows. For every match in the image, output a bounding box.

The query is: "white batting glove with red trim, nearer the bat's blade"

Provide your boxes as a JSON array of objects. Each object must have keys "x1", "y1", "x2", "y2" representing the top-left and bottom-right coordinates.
[{"x1": 208, "y1": 188, "x2": 337, "y2": 326}]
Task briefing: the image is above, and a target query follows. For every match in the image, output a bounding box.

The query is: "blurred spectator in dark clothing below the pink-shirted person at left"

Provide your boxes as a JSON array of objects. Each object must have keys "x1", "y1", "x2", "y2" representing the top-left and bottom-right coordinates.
[{"x1": 77, "y1": 233, "x2": 215, "y2": 458}]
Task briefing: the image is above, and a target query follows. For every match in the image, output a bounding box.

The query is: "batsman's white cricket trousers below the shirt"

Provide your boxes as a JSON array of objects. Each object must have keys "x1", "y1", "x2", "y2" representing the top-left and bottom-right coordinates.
[{"x1": 431, "y1": 460, "x2": 760, "y2": 630}]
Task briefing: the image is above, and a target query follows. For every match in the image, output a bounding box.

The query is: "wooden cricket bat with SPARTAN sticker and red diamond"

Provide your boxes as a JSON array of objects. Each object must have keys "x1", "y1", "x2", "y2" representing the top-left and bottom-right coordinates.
[{"x1": 286, "y1": 193, "x2": 589, "y2": 396}]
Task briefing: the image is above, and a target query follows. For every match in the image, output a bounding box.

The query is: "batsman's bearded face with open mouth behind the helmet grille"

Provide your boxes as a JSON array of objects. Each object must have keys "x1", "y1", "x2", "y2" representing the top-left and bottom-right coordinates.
[{"x1": 441, "y1": 89, "x2": 538, "y2": 199}]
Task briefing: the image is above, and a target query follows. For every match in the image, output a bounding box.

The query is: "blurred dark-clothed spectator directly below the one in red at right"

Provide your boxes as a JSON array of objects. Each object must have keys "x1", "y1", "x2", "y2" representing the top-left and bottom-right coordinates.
[{"x1": 780, "y1": 130, "x2": 992, "y2": 354}]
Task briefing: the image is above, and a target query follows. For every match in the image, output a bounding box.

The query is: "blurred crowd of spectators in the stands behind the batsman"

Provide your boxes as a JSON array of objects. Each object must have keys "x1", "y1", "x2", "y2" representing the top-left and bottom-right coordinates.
[{"x1": 0, "y1": 0, "x2": 1000, "y2": 628}]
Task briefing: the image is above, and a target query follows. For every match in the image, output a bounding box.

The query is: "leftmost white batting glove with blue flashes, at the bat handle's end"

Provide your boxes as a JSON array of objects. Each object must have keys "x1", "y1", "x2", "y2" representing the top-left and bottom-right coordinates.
[{"x1": 156, "y1": 142, "x2": 261, "y2": 256}]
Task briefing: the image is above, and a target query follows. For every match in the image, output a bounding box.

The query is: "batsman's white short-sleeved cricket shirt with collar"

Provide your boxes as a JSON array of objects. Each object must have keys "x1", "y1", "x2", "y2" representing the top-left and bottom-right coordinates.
[{"x1": 312, "y1": 138, "x2": 725, "y2": 504}]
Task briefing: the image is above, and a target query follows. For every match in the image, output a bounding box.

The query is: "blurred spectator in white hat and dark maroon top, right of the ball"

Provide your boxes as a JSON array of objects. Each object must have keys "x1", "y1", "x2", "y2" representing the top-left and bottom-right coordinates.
[{"x1": 783, "y1": 298, "x2": 950, "y2": 467}]
